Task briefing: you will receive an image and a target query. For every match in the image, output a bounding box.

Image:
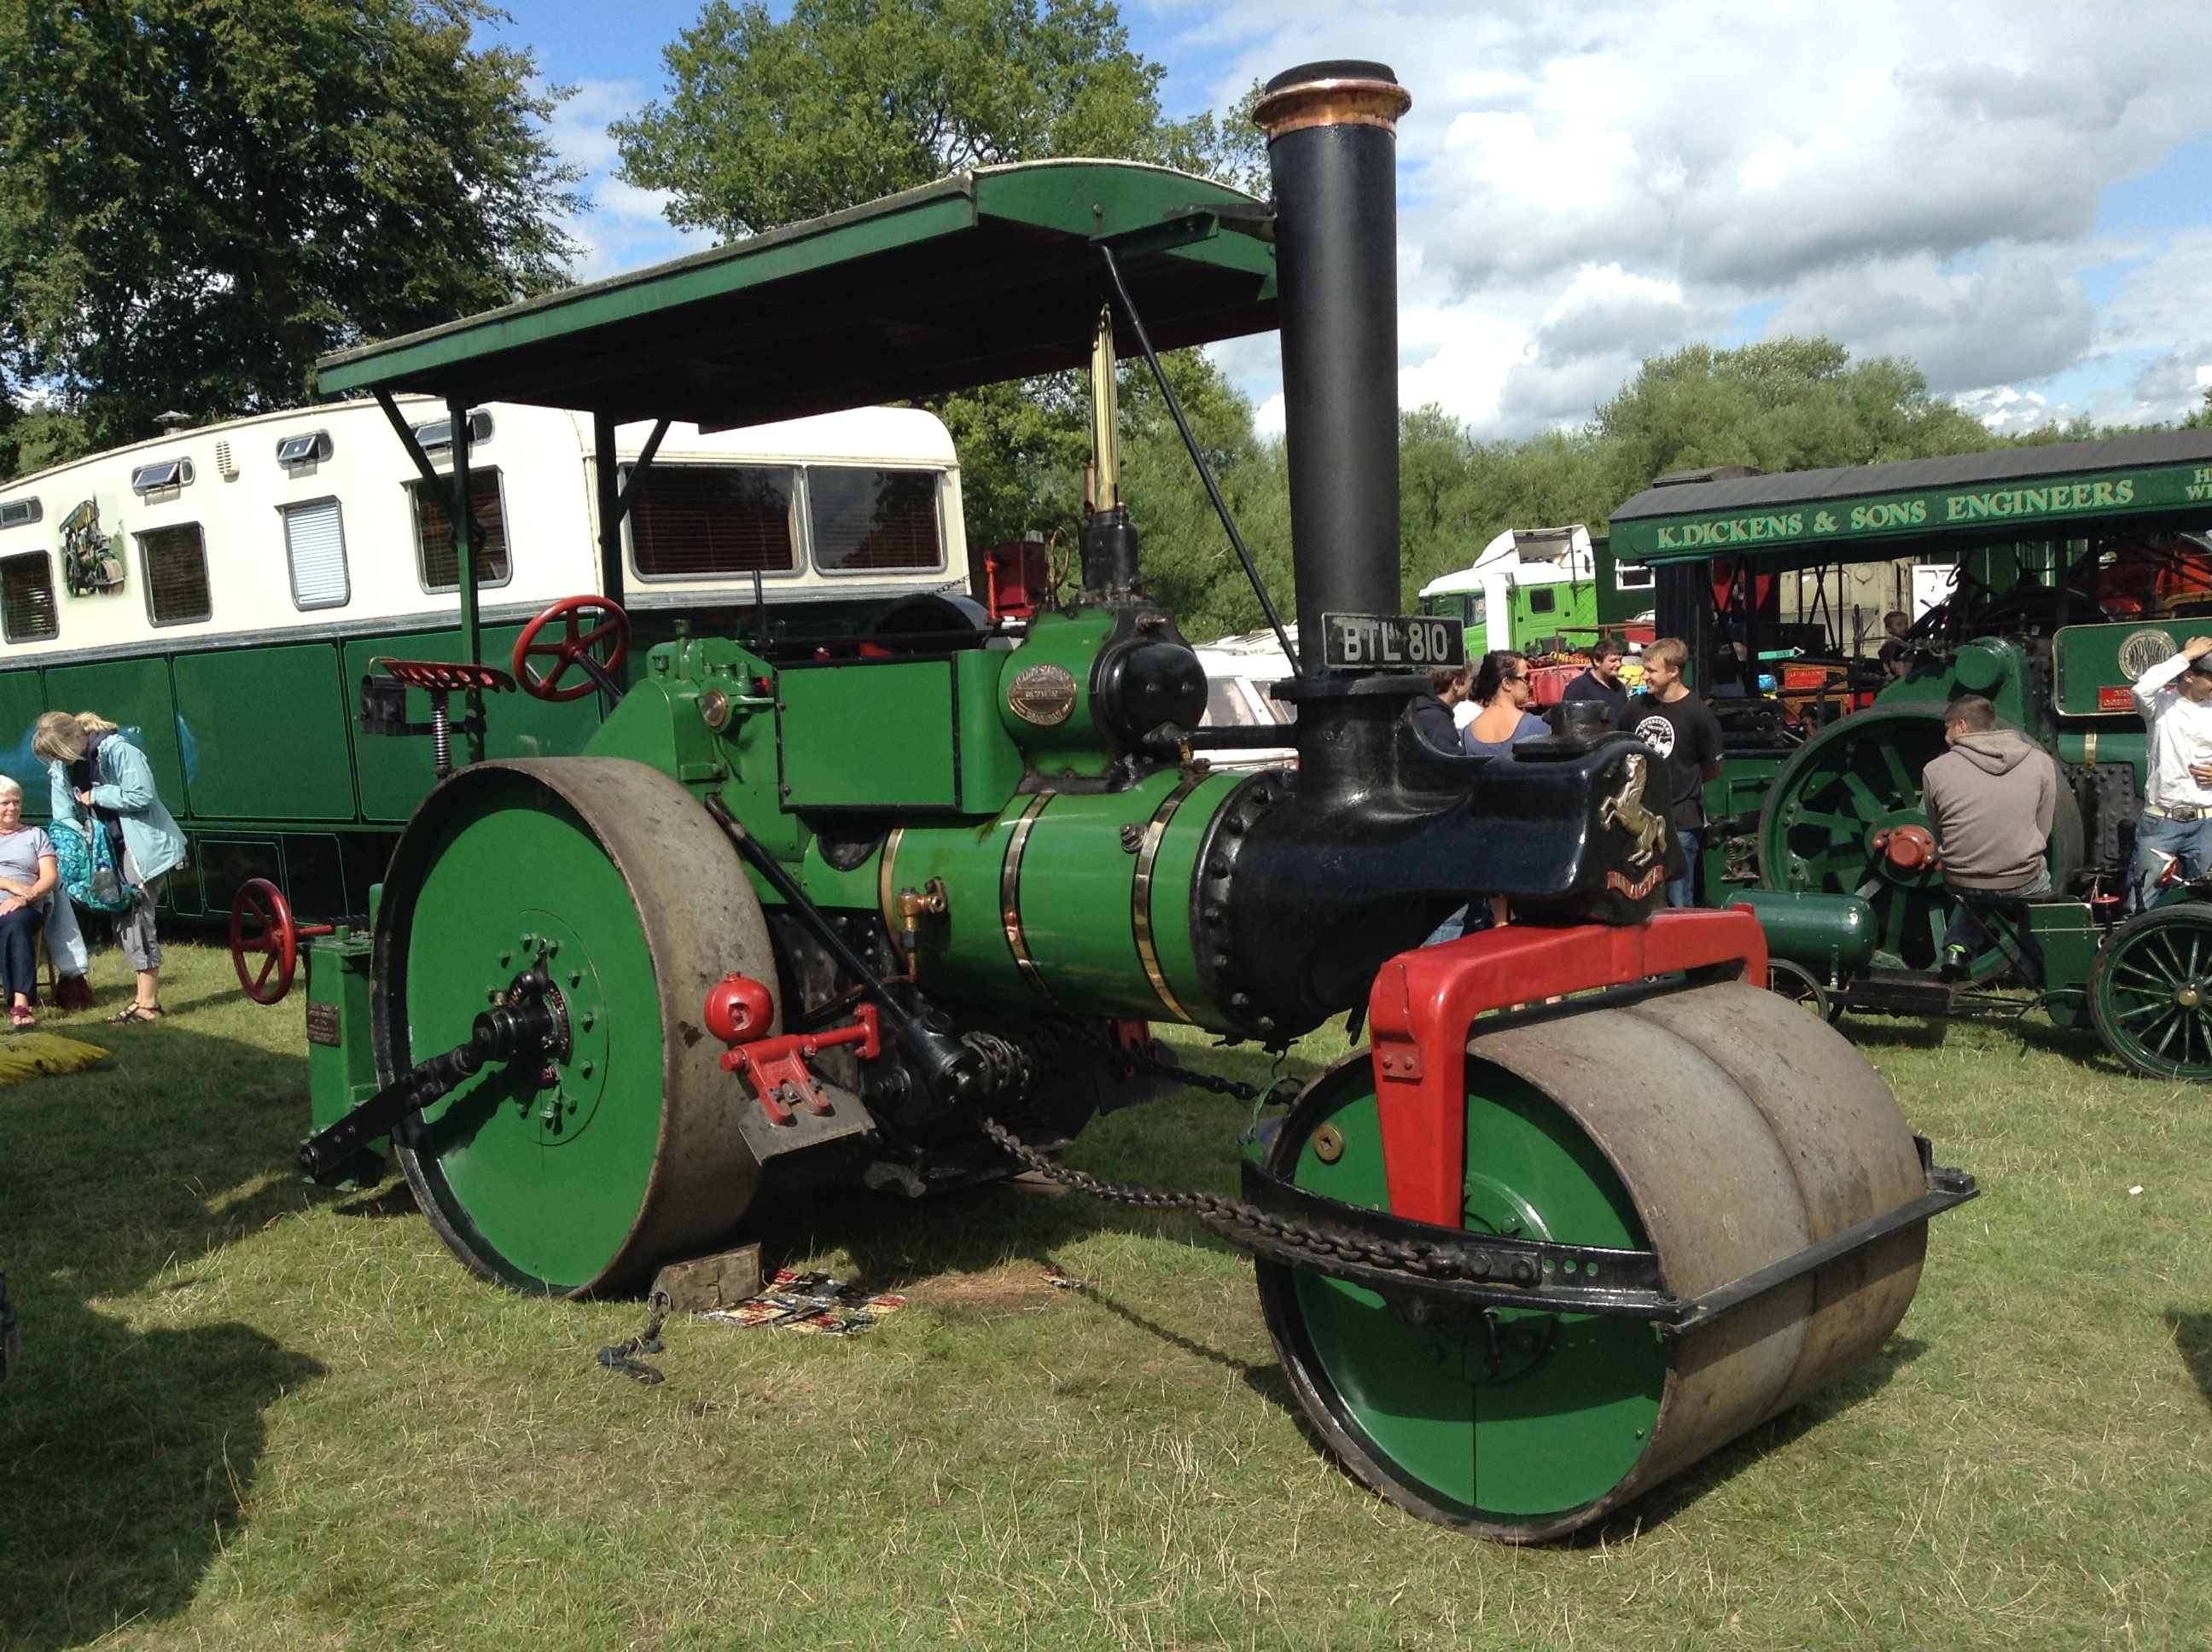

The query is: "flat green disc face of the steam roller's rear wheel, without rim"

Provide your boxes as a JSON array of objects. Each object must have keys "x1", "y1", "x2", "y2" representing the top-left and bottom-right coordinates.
[{"x1": 407, "y1": 789, "x2": 661, "y2": 1287}]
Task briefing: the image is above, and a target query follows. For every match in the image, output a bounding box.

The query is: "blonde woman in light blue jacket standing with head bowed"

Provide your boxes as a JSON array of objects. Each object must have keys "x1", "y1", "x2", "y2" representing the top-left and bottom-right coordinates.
[{"x1": 31, "y1": 713, "x2": 183, "y2": 1021}]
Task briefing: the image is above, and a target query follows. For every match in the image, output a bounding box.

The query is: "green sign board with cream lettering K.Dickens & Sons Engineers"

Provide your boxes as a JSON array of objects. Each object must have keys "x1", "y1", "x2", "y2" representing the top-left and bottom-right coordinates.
[{"x1": 1613, "y1": 464, "x2": 2212, "y2": 561}]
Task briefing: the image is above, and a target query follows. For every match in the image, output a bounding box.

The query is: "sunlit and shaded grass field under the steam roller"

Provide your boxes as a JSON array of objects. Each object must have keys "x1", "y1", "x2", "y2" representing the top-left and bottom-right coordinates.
[{"x1": 0, "y1": 949, "x2": 2212, "y2": 1652}]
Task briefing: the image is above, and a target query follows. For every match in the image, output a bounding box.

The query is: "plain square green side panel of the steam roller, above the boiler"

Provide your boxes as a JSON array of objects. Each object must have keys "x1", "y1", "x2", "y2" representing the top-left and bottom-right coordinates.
[{"x1": 777, "y1": 659, "x2": 960, "y2": 810}]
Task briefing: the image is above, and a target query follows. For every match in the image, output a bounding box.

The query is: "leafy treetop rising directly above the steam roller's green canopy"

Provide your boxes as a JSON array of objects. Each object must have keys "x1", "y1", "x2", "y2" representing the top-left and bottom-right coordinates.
[{"x1": 613, "y1": 0, "x2": 1259, "y2": 236}]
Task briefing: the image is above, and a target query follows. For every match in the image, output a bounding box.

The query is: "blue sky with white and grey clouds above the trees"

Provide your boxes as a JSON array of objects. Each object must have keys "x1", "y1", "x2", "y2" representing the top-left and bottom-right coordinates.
[{"x1": 493, "y1": 0, "x2": 2212, "y2": 436}]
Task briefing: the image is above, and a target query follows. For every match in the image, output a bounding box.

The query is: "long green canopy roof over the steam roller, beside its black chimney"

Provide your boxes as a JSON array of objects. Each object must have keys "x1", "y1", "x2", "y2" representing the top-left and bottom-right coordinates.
[{"x1": 321, "y1": 161, "x2": 1274, "y2": 427}]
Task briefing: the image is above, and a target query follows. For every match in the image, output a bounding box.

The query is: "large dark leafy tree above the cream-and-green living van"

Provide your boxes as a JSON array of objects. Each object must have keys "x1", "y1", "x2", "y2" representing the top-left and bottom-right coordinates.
[{"x1": 0, "y1": 0, "x2": 578, "y2": 457}]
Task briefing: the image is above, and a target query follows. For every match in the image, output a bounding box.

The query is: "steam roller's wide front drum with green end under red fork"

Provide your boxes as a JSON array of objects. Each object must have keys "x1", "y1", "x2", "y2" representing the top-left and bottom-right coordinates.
[{"x1": 1259, "y1": 982, "x2": 1927, "y2": 1544}]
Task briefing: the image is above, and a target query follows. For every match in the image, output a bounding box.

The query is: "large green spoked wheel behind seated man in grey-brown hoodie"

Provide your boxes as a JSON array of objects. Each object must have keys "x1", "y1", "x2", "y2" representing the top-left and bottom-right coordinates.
[{"x1": 1759, "y1": 703, "x2": 2081, "y2": 980}]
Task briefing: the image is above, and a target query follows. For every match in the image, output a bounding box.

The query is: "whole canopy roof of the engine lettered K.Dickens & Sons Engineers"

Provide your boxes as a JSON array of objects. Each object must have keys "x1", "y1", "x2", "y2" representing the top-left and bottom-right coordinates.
[{"x1": 1613, "y1": 429, "x2": 2212, "y2": 568}]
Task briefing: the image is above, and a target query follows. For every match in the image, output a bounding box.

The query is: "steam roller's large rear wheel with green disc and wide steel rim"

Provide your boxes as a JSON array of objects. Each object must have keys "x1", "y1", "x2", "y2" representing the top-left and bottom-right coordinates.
[{"x1": 376, "y1": 759, "x2": 777, "y2": 1296}]
